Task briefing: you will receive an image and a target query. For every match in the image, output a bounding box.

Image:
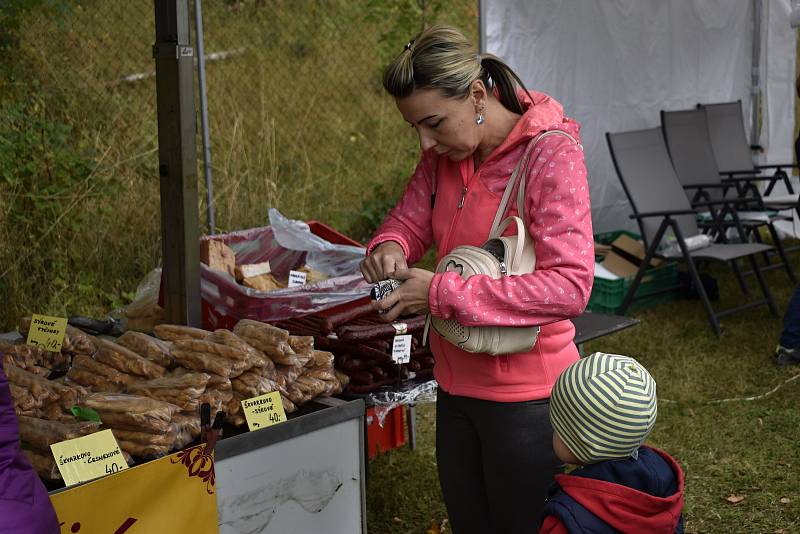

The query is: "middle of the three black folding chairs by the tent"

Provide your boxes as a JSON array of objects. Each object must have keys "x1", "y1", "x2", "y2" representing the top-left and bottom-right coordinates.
[{"x1": 661, "y1": 108, "x2": 797, "y2": 284}]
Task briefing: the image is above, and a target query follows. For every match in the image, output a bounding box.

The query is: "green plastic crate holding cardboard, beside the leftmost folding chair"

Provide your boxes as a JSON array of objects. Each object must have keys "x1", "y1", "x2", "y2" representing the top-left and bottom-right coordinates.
[{"x1": 586, "y1": 230, "x2": 678, "y2": 314}]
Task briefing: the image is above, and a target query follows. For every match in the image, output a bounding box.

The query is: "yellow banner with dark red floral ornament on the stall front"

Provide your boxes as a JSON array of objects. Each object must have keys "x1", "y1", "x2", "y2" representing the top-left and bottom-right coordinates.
[{"x1": 50, "y1": 445, "x2": 219, "y2": 534}]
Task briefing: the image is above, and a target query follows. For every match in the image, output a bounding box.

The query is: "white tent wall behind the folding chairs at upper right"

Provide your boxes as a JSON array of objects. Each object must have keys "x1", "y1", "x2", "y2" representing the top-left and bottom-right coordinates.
[{"x1": 481, "y1": 0, "x2": 796, "y2": 232}]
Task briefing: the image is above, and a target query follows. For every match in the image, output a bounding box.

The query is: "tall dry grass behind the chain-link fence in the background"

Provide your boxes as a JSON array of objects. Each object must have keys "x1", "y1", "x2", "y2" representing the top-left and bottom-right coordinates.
[{"x1": 0, "y1": 0, "x2": 477, "y2": 329}]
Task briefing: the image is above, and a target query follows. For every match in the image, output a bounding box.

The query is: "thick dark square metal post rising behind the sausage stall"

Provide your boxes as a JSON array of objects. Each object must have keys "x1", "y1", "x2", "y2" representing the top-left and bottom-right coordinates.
[{"x1": 153, "y1": 0, "x2": 201, "y2": 326}]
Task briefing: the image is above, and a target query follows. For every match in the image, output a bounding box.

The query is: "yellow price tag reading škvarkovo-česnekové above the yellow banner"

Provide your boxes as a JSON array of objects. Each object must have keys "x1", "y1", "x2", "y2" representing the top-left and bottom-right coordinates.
[{"x1": 50, "y1": 430, "x2": 128, "y2": 486}]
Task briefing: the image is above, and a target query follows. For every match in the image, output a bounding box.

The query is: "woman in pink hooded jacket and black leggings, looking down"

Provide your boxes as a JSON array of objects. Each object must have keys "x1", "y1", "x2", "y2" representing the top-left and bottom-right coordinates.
[{"x1": 362, "y1": 26, "x2": 594, "y2": 534}]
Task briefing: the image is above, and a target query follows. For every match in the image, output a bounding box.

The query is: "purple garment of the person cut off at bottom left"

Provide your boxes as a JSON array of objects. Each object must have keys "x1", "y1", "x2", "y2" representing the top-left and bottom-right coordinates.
[{"x1": 0, "y1": 360, "x2": 60, "y2": 534}]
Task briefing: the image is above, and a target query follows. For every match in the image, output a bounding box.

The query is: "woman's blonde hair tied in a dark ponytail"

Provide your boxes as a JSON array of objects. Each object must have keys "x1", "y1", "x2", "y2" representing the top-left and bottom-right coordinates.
[{"x1": 383, "y1": 25, "x2": 525, "y2": 115}]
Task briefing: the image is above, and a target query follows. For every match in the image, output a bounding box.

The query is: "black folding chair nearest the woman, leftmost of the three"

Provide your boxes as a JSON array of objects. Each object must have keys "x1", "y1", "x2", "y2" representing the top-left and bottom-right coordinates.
[{"x1": 606, "y1": 128, "x2": 778, "y2": 337}]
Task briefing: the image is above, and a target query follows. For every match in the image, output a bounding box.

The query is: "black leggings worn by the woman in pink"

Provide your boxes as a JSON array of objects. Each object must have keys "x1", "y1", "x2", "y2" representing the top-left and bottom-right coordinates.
[{"x1": 436, "y1": 388, "x2": 562, "y2": 534}]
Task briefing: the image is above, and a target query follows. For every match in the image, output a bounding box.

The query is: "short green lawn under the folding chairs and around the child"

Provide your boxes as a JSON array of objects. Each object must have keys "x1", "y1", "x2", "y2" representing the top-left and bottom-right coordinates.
[{"x1": 367, "y1": 253, "x2": 800, "y2": 534}]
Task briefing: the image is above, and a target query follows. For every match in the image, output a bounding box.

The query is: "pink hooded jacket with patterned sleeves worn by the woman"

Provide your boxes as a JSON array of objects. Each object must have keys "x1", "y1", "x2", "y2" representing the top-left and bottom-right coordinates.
[{"x1": 367, "y1": 91, "x2": 594, "y2": 402}]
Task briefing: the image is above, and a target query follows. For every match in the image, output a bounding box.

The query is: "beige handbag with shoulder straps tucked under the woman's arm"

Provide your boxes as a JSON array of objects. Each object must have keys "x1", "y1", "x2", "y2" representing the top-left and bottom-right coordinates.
[{"x1": 425, "y1": 130, "x2": 580, "y2": 356}]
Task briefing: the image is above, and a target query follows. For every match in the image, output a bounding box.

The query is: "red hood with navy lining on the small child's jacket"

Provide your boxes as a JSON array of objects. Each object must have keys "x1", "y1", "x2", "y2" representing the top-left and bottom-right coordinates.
[{"x1": 556, "y1": 446, "x2": 684, "y2": 532}]
